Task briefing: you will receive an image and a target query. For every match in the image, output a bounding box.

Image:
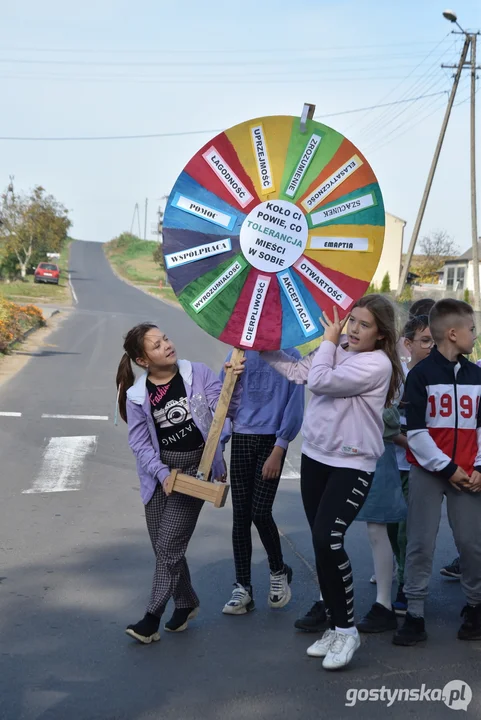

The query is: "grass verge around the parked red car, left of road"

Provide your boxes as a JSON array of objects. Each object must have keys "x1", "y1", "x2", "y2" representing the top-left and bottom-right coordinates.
[{"x1": 0, "y1": 238, "x2": 73, "y2": 305}]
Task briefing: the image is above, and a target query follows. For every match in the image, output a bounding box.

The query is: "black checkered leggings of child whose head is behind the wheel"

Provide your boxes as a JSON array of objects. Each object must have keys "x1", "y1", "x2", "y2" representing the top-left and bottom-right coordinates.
[{"x1": 230, "y1": 433, "x2": 284, "y2": 586}]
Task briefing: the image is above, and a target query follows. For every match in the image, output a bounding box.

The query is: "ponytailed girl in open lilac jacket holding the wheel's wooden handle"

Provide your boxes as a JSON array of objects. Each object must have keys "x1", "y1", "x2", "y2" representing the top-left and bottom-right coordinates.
[{"x1": 117, "y1": 323, "x2": 244, "y2": 644}]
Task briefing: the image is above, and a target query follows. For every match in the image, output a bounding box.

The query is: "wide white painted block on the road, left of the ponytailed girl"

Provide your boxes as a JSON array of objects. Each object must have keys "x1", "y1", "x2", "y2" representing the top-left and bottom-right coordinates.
[{"x1": 22, "y1": 435, "x2": 97, "y2": 495}]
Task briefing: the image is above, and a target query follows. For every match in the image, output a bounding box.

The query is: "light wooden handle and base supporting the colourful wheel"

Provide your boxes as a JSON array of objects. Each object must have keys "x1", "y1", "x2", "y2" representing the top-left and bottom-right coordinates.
[{"x1": 165, "y1": 348, "x2": 244, "y2": 507}]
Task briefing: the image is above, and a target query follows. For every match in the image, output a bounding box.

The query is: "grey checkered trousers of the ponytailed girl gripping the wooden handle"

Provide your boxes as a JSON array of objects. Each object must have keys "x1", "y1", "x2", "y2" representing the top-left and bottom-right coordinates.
[{"x1": 145, "y1": 447, "x2": 204, "y2": 617}]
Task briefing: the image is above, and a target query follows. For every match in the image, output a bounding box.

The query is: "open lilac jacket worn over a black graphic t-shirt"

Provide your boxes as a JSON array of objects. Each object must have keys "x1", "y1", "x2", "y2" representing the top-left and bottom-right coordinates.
[{"x1": 127, "y1": 360, "x2": 242, "y2": 505}]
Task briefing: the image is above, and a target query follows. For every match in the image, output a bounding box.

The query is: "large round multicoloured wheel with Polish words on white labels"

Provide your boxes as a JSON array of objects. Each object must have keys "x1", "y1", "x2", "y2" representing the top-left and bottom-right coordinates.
[{"x1": 163, "y1": 116, "x2": 384, "y2": 350}]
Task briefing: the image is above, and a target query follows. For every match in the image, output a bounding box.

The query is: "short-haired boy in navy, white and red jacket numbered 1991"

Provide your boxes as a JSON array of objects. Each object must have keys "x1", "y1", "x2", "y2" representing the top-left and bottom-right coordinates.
[{"x1": 393, "y1": 299, "x2": 481, "y2": 645}]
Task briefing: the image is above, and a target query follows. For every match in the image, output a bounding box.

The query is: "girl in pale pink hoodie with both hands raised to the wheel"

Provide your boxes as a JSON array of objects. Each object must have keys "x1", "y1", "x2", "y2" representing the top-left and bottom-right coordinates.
[{"x1": 262, "y1": 294, "x2": 402, "y2": 670}]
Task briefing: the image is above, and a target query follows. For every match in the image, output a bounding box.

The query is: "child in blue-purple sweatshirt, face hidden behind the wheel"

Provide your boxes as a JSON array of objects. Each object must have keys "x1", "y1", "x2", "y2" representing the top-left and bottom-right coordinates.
[{"x1": 221, "y1": 349, "x2": 304, "y2": 615}]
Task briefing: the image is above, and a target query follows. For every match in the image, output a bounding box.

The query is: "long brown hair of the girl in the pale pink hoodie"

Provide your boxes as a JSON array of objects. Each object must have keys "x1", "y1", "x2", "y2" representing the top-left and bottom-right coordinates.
[{"x1": 353, "y1": 293, "x2": 404, "y2": 407}]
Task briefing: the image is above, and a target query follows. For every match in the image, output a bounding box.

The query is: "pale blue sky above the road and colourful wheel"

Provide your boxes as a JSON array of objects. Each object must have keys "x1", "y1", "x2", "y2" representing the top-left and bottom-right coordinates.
[{"x1": 0, "y1": 0, "x2": 481, "y2": 250}]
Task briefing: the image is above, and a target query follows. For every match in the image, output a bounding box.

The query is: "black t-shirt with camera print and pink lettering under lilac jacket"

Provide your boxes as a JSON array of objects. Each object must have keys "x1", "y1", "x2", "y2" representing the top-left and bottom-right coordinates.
[{"x1": 147, "y1": 372, "x2": 204, "y2": 452}]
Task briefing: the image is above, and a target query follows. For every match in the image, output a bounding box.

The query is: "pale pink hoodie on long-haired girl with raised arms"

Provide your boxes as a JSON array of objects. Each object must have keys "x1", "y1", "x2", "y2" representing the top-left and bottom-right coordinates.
[{"x1": 261, "y1": 340, "x2": 392, "y2": 472}]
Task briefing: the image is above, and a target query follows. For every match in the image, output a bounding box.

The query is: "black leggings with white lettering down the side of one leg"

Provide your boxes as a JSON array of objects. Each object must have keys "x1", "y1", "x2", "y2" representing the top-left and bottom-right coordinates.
[{"x1": 301, "y1": 454, "x2": 374, "y2": 628}]
